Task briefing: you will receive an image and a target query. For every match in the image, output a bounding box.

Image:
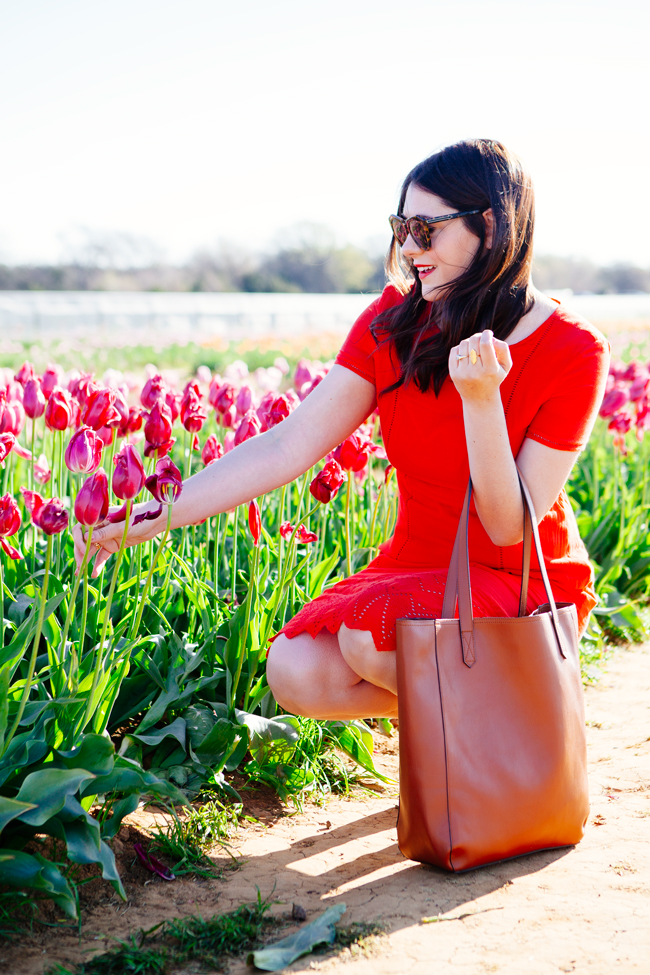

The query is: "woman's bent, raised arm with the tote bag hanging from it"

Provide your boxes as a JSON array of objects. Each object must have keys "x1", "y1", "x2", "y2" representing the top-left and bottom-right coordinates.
[{"x1": 449, "y1": 329, "x2": 578, "y2": 546}]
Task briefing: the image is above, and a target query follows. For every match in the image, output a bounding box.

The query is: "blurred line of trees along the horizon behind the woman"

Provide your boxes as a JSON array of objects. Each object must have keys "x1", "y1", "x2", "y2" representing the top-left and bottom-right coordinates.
[{"x1": 0, "y1": 225, "x2": 650, "y2": 294}]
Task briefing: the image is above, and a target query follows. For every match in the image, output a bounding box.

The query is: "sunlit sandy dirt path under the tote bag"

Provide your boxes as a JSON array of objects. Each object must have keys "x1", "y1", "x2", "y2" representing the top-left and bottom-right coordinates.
[{"x1": 0, "y1": 647, "x2": 650, "y2": 975}]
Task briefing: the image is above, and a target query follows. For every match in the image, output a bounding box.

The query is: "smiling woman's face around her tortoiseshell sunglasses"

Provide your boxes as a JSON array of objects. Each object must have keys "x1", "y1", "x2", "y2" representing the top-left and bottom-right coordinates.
[{"x1": 402, "y1": 183, "x2": 491, "y2": 301}]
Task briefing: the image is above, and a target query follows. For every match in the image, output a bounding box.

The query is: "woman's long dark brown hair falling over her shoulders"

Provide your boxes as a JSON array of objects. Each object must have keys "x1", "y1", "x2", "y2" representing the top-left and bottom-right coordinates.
[{"x1": 371, "y1": 139, "x2": 535, "y2": 396}]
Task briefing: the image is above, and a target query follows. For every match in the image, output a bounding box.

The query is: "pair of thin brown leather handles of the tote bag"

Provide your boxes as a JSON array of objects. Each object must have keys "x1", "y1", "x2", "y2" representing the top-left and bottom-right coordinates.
[{"x1": 442, "y1": 468, "x2": 566, "y2": 667}]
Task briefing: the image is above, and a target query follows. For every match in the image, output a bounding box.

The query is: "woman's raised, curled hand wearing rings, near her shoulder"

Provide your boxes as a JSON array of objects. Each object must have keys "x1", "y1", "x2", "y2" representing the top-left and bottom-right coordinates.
[{"x1": 449, "y1": 328, "x2": 512, "y2": 404}]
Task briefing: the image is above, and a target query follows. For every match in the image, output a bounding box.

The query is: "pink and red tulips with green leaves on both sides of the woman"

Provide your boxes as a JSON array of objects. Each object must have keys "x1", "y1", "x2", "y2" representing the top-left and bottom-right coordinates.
[{"x1": 0, "y1": 348, "x2": 650, "y2": 918}]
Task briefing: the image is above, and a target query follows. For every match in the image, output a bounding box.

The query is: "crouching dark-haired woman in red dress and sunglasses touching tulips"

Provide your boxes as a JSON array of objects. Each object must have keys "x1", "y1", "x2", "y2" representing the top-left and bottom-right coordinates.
[{"x1": 76, "y1": 139, "x2": 608, "y2": 719}]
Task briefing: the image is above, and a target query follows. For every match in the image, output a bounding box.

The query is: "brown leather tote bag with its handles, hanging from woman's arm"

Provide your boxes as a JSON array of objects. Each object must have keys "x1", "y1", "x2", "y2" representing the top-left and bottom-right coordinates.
[{"x1": 397, "y1": 475, "x2": 589, "y2": 871}]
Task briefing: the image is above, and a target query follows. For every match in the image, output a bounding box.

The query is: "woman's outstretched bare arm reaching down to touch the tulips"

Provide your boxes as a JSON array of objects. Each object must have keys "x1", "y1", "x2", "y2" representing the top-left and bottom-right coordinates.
[{"x1": 74, "y1": 365, "x2": 375, "y2": 574}]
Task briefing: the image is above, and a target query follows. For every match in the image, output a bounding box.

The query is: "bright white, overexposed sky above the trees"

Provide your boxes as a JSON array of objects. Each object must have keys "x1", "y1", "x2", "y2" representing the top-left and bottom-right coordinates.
[{"x1": 0, "y1": 0, "x2": 650, "y2": 266}]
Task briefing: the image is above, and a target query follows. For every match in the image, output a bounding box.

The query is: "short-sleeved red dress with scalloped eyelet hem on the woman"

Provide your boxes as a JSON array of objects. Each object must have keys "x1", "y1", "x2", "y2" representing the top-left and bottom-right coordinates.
[{"x1": 281, "y1": 287, "x2": 609, "y2": 650}]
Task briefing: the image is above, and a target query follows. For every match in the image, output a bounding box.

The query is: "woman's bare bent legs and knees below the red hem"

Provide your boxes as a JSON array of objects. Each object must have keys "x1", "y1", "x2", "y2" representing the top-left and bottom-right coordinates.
[{"x1": 266, "y1": 627, "x2": 397, "y2": 721}]
